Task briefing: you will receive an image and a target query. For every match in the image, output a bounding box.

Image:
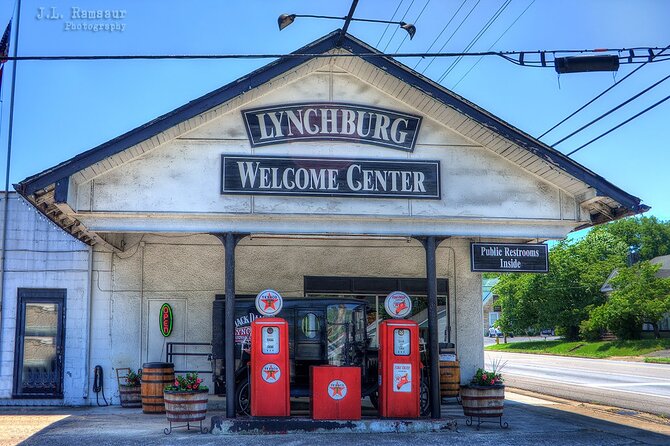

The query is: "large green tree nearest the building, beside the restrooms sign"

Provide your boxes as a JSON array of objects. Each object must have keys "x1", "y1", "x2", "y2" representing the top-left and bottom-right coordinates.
[{"x1": 495, "y1": 231, "x2": 627, "y2": 339}]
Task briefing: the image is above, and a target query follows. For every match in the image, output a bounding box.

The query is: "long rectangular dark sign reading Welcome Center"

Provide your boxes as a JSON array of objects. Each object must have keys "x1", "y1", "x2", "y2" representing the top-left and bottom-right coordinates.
[{"x1": 221, "y1": 155, "x2": 440, "y2": 199}]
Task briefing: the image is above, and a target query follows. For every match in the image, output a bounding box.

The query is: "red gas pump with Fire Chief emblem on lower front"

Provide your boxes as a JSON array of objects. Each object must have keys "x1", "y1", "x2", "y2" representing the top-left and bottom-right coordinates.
[{"x1": 379, "y1": 291, "x2": 421, "y2": 418}]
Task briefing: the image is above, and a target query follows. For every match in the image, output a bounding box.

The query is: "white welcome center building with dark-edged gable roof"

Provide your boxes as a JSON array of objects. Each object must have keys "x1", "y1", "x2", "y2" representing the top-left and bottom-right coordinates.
[{"x1": 0, "y1": 32, "x2": 647, "y2": 414}]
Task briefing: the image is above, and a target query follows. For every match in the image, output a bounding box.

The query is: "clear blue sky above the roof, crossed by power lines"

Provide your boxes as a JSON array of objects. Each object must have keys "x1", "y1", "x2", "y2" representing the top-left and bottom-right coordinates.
[{"x1": 0, "y1": 0, "x2": 670, "y2": 220}]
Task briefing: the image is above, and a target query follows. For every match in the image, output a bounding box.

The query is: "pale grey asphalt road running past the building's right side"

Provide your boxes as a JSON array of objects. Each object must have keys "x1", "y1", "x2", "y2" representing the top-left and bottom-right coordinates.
[{"x1": 485, "y1": 351, "x2": 670, "y2": 417}]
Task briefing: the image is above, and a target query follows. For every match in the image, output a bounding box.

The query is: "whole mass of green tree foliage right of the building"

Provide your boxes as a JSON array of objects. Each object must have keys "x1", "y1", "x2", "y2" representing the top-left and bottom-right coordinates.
[{"x1": 494, "y1": 217, "x2": 670, "y2": 339}]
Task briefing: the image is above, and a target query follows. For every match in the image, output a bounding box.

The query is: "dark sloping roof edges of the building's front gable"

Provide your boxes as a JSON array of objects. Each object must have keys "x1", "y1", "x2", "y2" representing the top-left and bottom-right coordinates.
[{"x1": 14, "y1": 30, "x2": 649, "y2": 247}]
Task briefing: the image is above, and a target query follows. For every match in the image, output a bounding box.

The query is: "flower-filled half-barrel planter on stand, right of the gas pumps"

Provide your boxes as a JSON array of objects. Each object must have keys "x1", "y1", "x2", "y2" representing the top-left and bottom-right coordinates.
[{"x1": 461, "y1": 364, "x2": 508, "y2": 429}]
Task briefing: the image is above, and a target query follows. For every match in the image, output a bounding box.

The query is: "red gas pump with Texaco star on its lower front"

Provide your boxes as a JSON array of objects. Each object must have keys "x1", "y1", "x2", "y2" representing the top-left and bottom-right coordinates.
[{"x1": 250, "y1": 290, "x2": 291, "y2": 417}]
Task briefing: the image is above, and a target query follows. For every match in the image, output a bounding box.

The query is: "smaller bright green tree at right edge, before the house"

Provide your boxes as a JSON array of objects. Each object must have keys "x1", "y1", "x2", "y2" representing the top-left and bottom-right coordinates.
[{"x1": 589, "y1": 261, "x2": 670, "y2": 339}]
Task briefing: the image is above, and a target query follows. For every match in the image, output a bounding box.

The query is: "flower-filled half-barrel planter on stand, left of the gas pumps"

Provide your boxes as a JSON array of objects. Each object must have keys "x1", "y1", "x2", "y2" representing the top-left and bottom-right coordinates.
[{"x1": 163, "y1": 373, "x2": 209, "y2": 434}]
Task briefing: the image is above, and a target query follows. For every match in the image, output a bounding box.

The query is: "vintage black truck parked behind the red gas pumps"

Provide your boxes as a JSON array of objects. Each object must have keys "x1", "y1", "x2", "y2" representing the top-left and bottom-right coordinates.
[{"x1": 212, "y1": 296, "x2": 429, "y2": 414}]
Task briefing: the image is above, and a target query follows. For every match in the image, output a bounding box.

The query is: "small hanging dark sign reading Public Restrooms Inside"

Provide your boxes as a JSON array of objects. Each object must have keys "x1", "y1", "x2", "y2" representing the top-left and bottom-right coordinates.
[{"x1": 470, "y1": 243, "x2": 549, "y2": 273}]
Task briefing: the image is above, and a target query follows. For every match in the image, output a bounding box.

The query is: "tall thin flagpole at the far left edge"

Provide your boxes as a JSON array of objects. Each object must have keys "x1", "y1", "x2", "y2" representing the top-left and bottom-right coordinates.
[{"x1": 0, "y1": 0, "x2": 21, "y2": 380}]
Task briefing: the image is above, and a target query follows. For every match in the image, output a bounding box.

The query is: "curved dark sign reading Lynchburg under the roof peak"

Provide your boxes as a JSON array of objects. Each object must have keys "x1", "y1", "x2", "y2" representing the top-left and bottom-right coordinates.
[{"x1": 242, "y1": 102, "x2": 421, "y2": 152}]
